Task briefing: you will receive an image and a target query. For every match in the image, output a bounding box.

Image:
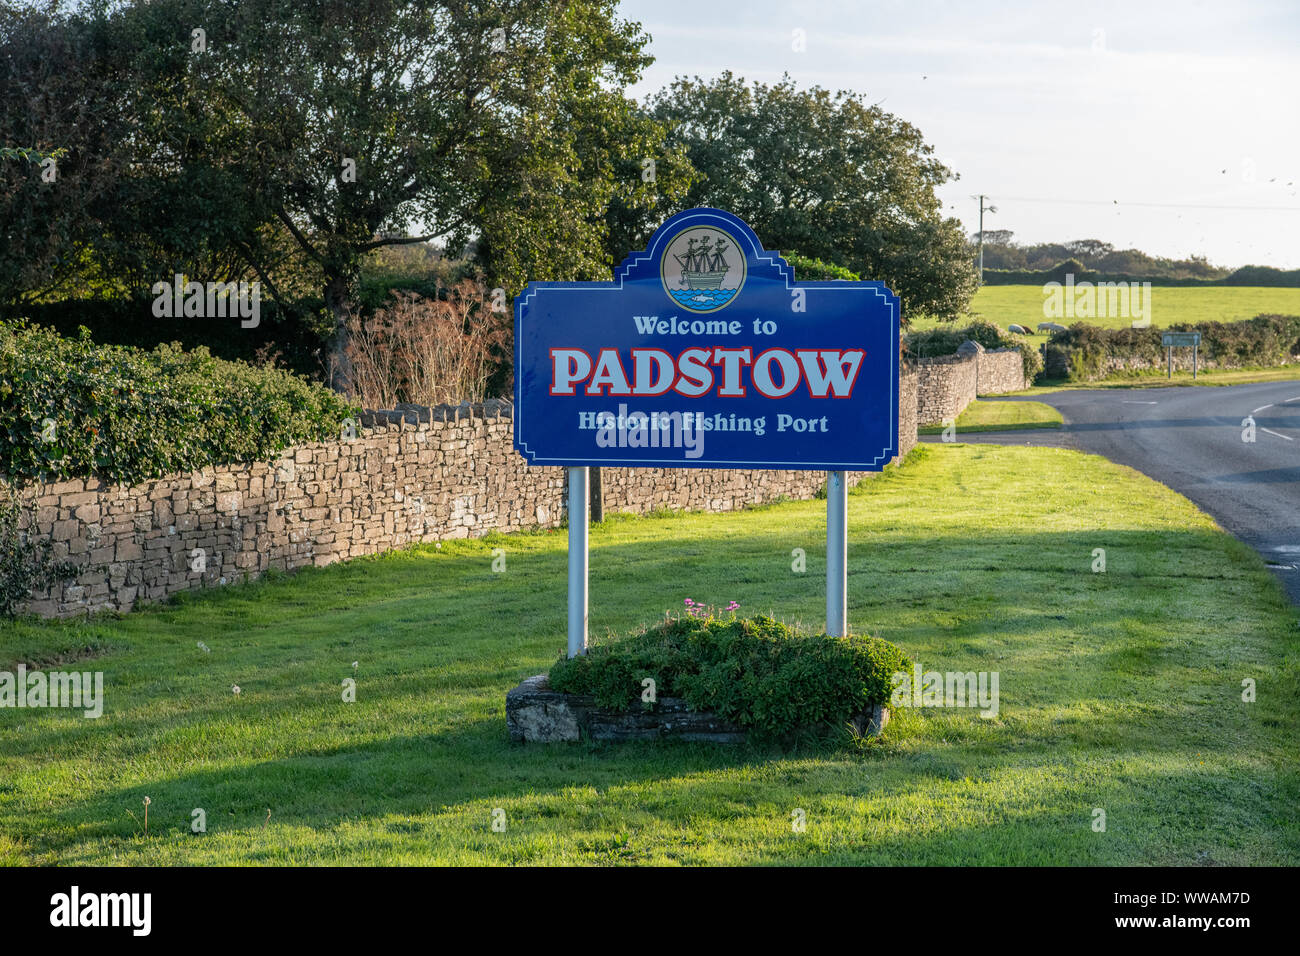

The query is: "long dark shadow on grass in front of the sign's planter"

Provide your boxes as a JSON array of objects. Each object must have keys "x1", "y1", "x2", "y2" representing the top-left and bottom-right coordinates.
[{"x1": 47, "y1": 718, "x2": 790, "y2": 856}]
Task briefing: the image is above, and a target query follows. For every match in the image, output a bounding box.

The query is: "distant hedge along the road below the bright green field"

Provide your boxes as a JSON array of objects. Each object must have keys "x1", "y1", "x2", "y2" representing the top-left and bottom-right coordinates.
[{"x1": 1047, "y1": 315, "x2": 1300, "y2": 381}]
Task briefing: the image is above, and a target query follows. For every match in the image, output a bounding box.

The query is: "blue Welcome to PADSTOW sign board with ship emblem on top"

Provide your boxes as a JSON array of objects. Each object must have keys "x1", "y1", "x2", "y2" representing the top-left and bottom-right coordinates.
[{"x1": 515, "y1": 208, "x2": 900, "y2": 471}]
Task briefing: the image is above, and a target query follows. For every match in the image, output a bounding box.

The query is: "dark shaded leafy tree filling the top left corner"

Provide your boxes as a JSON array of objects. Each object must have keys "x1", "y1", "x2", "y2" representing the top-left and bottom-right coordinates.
[{"x1": 0, "y1": 0, "x2": 283, "y2": 303}]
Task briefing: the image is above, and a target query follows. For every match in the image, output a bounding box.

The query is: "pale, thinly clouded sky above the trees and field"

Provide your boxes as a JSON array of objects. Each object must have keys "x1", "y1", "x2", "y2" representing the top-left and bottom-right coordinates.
[{"x1": 619, "y1": 0, "x2": 1300, "y2": 268}]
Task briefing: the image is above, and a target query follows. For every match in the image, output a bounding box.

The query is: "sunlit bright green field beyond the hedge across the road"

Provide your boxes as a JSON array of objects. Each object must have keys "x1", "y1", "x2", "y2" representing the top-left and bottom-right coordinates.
[{"x1": 911, "y1": 285, "x2": 1300, "y2": 339}]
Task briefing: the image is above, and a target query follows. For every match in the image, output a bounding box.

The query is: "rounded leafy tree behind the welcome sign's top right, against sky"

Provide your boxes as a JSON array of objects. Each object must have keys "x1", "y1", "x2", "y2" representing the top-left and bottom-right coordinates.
[{"x1": 650, "y1": 73, "x2": 976, "y2": 317}]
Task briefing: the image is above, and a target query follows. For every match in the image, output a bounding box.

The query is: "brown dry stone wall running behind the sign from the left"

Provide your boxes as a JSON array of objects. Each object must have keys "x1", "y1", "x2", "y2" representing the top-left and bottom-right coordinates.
[{"x1": 15, "y1": 372, "x2": 918, "y2": 617}]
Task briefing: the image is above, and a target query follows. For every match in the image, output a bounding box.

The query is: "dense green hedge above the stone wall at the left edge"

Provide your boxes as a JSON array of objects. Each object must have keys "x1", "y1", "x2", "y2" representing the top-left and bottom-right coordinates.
[{"x1": 0, "y1": 323, "x2": 359, "y2": 483}]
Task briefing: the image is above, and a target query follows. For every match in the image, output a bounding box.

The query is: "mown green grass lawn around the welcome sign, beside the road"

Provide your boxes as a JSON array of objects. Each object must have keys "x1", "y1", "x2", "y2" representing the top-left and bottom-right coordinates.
[{"x1": 0, "y1": 445, "x2": 1300, "y2": 865}]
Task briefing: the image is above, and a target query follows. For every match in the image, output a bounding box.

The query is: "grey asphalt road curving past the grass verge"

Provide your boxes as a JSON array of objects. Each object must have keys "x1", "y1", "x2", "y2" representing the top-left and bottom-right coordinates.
[{"x1": 920, "y1": 381, "x2": 1300, "y2": 605}]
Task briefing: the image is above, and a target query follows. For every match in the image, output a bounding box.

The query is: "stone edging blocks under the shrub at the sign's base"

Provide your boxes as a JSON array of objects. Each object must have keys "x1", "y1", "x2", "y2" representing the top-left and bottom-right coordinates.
[{"x1": 506, "y1": 674, "x2": 889, "y2": 744}]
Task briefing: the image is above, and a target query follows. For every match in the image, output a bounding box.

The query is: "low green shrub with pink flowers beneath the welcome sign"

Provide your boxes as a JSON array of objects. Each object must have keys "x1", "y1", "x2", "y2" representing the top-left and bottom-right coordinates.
[{"x1": 550, "y1": 615, "x2": 911, "y2": 736}]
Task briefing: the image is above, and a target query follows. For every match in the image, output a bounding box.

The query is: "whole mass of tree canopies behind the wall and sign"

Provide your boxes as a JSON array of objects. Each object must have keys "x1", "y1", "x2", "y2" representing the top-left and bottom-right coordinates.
[{"x1": 0, "y1": 8, "x2": 975, "y2": 369}]
